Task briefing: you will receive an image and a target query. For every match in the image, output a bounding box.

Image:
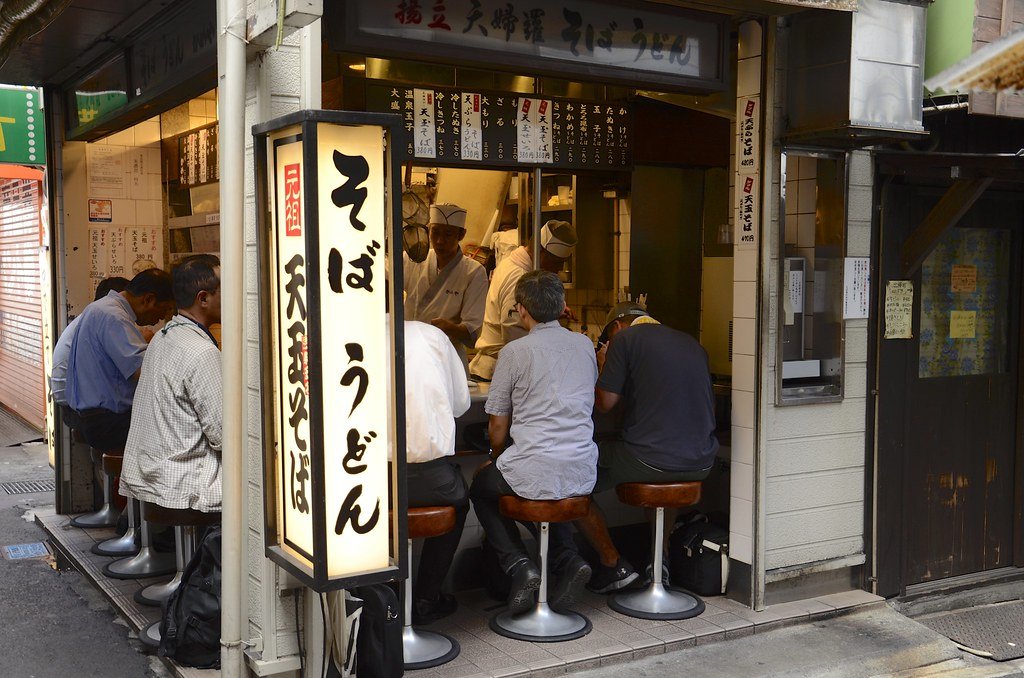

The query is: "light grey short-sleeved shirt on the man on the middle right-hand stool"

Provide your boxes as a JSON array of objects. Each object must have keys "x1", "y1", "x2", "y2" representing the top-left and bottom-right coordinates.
[{"x1": 484, "y1": 321, "x2": 597, "y2": 499}]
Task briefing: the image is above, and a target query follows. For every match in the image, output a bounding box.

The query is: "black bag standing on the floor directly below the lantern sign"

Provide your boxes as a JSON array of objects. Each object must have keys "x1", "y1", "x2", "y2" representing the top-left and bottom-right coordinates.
[{"x1": 352, "y1": 584, "x2": 404, "y2": 678}]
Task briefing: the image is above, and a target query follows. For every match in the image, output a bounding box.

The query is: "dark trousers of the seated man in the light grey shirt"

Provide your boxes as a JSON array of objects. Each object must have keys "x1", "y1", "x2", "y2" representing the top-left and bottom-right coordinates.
[{"x1": 469, "y1": 464, "x2": 577, "y2": 574}]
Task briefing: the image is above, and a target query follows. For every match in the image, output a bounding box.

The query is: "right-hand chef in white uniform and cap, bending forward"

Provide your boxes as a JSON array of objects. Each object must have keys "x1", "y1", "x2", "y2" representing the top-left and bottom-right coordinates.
[{"x1": 469, "y1": 219, "x2": 577, "y2": 381}]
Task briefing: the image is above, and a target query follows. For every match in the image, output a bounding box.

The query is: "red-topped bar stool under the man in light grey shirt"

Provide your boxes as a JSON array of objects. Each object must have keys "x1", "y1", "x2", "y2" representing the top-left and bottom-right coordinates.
[{"x1": 490, "y1": 495, "x2": 592, "y2": 643}]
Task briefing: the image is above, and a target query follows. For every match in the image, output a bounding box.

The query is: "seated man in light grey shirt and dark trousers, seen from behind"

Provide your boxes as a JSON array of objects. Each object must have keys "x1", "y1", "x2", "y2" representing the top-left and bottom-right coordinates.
[{"x1": 469, "y1": 270, "x2": 597, "y2": 612}]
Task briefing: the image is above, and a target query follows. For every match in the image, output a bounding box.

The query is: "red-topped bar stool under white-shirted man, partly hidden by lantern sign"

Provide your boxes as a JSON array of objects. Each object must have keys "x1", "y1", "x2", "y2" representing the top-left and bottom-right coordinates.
[{"x1": 401, "y1": 506, "x2": 460, "y2": 671}]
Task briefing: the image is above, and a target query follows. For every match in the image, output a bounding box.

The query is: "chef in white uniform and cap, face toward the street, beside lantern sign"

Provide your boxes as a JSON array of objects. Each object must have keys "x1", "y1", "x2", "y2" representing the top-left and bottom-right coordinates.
[{"x1": 404, "y1": 204, "x2": 487, "y2": 366}]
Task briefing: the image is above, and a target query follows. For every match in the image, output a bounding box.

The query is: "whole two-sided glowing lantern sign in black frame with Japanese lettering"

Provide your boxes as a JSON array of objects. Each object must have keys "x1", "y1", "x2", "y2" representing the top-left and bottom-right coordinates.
[{"x1": 254, "y1": 111, "x2": 406, "y2": 591}]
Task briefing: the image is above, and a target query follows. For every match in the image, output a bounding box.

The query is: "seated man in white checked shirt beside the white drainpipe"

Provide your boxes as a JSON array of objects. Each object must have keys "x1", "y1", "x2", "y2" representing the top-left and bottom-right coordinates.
[{"x1": 121, "y1": 254, "x2": 223, "y2": 513}]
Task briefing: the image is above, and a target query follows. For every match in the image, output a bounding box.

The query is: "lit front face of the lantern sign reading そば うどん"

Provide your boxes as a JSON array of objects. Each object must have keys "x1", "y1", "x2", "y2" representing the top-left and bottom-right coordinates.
[{"x1": 316, "y1": 123, "x2": 391, "y2": 577}]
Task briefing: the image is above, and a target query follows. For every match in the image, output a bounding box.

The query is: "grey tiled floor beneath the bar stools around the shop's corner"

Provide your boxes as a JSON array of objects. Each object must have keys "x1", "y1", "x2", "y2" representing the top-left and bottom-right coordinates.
[{"x1": 37, "y1": 514, "x2": 882, "y2": 678}]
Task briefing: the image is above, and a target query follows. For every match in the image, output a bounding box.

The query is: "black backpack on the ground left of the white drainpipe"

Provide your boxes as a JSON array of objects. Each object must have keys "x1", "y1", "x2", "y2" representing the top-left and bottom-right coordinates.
[{"x1": 159, "y1": 527, "x2": 221, "y2": 669}]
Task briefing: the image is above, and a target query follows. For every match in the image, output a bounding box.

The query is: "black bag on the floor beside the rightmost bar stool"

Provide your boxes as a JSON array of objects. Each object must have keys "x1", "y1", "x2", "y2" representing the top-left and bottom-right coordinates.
[{"x1": 669, "y1": 512, "x2": 729, "y2": 596}]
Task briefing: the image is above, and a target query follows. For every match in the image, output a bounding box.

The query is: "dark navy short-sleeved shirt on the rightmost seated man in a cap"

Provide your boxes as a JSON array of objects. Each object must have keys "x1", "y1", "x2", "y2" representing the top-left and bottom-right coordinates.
[{"x1": 597, "y1": 325, "x2": 718, "y2": 471}]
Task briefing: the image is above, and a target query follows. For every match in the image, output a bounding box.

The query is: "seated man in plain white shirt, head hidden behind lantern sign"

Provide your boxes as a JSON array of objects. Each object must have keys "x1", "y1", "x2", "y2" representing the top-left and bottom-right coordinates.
[{"x1": 404, "y1": 322, "x2": 470, "y2": 624}]
